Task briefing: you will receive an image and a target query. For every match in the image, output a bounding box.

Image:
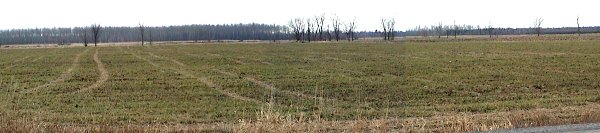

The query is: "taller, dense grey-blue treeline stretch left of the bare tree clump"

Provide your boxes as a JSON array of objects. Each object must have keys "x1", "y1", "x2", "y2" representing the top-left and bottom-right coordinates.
[{"x1": 0, "y1": 23, "x2": 289, "y2": 44}]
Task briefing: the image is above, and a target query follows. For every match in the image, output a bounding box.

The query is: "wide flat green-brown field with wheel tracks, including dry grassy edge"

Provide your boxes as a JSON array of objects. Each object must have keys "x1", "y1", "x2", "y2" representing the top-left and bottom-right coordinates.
[{"x1": 0, "y1": 37, "x2": 600, "y2": 132}]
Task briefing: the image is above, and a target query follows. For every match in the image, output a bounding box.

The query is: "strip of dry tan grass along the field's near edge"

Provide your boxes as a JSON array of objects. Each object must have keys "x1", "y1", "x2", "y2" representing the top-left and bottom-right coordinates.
[{"x1": 0, "y1": 104, "x2": 600, "y2": 133}]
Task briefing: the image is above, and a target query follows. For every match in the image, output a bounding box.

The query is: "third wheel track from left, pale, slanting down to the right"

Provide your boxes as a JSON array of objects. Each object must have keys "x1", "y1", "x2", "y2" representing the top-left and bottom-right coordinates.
[{"x1": 121, "y1": 47, "x2": 265, "y2": 104}]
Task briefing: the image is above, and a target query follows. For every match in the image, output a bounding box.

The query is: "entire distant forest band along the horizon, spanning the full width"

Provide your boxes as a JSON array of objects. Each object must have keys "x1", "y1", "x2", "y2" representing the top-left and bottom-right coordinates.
[{"x1": 0, "y1": 23, "x2": 600, "y2": 45}]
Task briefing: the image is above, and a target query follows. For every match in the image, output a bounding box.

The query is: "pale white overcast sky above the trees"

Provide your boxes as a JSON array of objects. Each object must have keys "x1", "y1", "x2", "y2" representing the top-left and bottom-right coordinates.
[{"x1": 0, "y1": 0, "x2": 600, "y2": 30}]
